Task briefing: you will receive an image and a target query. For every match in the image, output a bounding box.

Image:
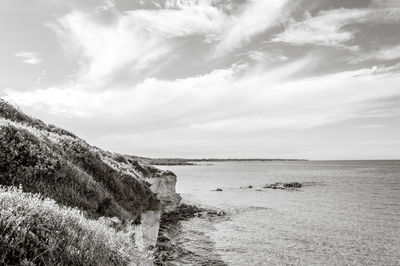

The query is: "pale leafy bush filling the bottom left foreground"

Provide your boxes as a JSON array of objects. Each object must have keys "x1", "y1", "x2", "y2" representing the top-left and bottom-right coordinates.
[{"x1": 0, "y1": 187, "x2": 149, "y2": 265}]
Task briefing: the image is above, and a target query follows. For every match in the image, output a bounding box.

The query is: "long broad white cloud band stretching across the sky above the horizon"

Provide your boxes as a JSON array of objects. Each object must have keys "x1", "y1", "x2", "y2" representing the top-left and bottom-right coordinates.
[{"x1": 5, "y1": 58, "x2": 400, "y2": 135}]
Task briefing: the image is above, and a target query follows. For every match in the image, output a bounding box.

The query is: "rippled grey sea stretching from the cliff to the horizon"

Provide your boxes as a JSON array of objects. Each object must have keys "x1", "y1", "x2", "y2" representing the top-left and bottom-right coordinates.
[{"x1": 159, "y1": 161, "x2": 400, "y2": 265}]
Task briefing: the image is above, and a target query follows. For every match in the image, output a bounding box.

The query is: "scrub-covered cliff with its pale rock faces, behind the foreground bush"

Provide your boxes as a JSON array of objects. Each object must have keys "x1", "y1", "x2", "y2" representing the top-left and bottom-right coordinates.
[{"x1": 0, "y1": 99, "x2": 180, "y2": 265}]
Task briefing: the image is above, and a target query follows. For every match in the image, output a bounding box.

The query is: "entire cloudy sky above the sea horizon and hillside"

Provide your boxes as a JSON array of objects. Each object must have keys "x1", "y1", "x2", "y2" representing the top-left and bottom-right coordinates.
[{"x1": 0, "y1": 0, "x2": 400, "y2": 160}]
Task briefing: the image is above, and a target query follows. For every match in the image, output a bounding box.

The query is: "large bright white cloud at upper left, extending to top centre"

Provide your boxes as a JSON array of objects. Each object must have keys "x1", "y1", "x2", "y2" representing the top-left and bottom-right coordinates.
[{"x1": 49, "y1": 2, "x2": 224, "y2": 86}]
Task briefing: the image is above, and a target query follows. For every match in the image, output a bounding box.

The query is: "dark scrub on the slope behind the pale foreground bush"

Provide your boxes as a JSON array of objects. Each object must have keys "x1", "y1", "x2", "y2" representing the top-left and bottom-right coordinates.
[{"x1": 0, "y1": 98, "x2": 160, "y2": 219}]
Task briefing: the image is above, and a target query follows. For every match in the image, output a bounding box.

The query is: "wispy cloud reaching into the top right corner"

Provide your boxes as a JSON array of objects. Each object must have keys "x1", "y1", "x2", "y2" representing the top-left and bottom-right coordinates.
[{"x1": 271, "y1": 1, "x2": 400, "y2": 47}]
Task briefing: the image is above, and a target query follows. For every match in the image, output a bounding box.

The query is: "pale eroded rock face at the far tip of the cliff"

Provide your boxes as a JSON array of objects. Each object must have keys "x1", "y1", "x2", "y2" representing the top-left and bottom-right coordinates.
[{"x1": 146, "y1": 174, "x2": 181, "y2": 212}]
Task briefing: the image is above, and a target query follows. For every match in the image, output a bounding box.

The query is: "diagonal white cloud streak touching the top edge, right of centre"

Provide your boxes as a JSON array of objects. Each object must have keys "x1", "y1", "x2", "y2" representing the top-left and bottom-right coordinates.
[{"x1": 216, "y1": 0, "x2": 288, "y2": 55}]
